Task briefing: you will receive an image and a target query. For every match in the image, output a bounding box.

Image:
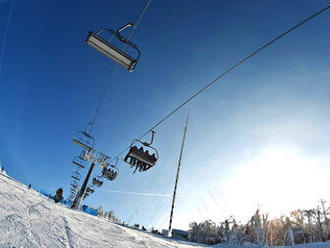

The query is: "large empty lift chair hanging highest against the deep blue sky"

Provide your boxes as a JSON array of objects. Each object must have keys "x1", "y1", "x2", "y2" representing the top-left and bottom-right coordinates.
[{"x1": 86, "y1": 23, "x2": 141, "y2": 71}]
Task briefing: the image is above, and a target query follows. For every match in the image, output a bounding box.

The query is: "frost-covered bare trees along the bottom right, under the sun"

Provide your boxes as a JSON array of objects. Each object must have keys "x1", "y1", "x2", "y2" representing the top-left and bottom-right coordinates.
[{"x1": 188, "y1": 199, "x2": 330, "y2": 246}]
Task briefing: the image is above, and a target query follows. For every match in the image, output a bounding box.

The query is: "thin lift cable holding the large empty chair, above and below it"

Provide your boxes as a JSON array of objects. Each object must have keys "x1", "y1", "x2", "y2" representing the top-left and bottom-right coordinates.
[{"x1": 90, "y1": 0, "x2": 152, "y2": 132}]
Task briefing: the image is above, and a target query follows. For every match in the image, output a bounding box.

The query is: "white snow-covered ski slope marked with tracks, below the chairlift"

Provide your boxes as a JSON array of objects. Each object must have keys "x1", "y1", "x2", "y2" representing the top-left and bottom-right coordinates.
[{"x1": 0, "y1": 174, "x2": 330, "y2": 248}]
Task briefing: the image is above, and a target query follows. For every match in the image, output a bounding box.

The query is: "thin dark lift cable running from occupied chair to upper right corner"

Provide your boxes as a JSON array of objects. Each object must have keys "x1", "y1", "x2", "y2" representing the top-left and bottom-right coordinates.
[{"x1": 111, "y1": 5, "x2": 330, "y2": 162}]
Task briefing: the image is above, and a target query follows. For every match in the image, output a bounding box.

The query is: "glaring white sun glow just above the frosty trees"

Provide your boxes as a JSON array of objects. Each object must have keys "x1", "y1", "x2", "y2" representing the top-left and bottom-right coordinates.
[{"x1": 225, "y1": 146, "x2": 330, "y2": 220}]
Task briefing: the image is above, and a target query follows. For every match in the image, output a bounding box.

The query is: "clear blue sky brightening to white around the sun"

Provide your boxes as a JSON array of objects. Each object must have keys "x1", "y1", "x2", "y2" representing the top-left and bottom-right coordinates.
[{"x1": 0, "y1": 0, "x2": 330, "y2": 231}]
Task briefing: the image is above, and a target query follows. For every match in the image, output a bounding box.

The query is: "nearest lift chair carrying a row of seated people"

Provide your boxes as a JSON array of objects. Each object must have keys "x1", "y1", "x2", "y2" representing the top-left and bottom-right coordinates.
[{"x1": 124, "y1": 130, "x2": 159, "y2": 172}]
